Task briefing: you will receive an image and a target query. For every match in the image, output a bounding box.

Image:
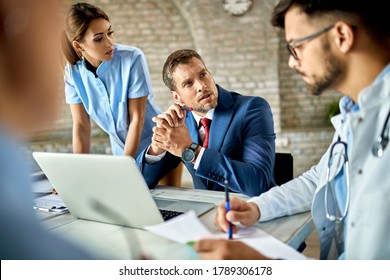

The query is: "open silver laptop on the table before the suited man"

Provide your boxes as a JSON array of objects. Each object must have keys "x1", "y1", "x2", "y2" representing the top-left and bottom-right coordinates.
[{"x1": 32, "y1": 152, "x2": 214, "y2": 228}]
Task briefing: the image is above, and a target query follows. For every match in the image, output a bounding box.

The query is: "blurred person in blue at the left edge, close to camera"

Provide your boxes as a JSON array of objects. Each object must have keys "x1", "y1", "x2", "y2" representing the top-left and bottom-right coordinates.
[{"x1": 0, "y1": 0, "x2": 89, "y2": 260}]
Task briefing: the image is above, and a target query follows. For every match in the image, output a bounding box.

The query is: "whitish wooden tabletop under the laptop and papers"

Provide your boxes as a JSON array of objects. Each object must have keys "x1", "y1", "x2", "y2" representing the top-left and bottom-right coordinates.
[{"x1": 37, "y1": 183, "x2": 312, "y2": 260}]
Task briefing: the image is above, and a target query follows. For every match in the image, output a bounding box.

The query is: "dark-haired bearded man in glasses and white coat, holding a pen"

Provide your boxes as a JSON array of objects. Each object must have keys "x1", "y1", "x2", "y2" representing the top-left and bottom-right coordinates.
[{"x1": 195, "y1": 0, "x2": 390, "y2": 259}]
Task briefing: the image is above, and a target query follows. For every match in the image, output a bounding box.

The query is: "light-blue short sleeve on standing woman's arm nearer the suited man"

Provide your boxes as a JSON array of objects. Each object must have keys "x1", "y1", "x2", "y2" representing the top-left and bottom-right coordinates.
[{"x1": 127, "y1": 49, "x2": 152, "y2": 98}]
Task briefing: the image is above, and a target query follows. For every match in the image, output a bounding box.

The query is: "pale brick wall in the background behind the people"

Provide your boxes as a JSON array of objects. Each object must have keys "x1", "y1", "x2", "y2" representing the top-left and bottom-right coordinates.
[{"x1": 25, "y1": 0, "x2": 338, "y2": 184}]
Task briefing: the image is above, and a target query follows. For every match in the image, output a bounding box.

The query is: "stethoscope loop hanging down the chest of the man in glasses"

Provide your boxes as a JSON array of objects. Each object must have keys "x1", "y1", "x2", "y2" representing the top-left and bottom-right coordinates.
[{"x1": 325, "y1": 136, "x2": 350, "y2": 222}]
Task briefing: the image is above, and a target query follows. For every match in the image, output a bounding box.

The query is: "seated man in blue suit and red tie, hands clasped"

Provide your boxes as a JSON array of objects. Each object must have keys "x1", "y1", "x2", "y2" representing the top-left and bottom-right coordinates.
[{"x1": 137, "y1": 50, "x2": 275, "y2": 196}]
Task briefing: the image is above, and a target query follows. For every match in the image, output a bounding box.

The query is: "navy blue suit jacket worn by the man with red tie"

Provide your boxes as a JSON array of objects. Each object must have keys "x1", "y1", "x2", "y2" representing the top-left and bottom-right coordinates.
[{"x1": 137, "y1": 86, "x2": 275, "y2": 196}]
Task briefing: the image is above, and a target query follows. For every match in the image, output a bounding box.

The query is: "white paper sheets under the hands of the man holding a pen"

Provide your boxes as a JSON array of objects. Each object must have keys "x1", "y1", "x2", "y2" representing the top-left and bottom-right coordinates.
[{"x1": 144, "y1": 211, "x2": 307, "y2": 260}]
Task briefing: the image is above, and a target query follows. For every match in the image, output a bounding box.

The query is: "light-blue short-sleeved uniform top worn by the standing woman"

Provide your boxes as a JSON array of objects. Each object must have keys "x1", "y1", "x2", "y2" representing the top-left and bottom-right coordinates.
[{"x1": 65, "y1": 44, "x2": 161, "y2": 155}]
